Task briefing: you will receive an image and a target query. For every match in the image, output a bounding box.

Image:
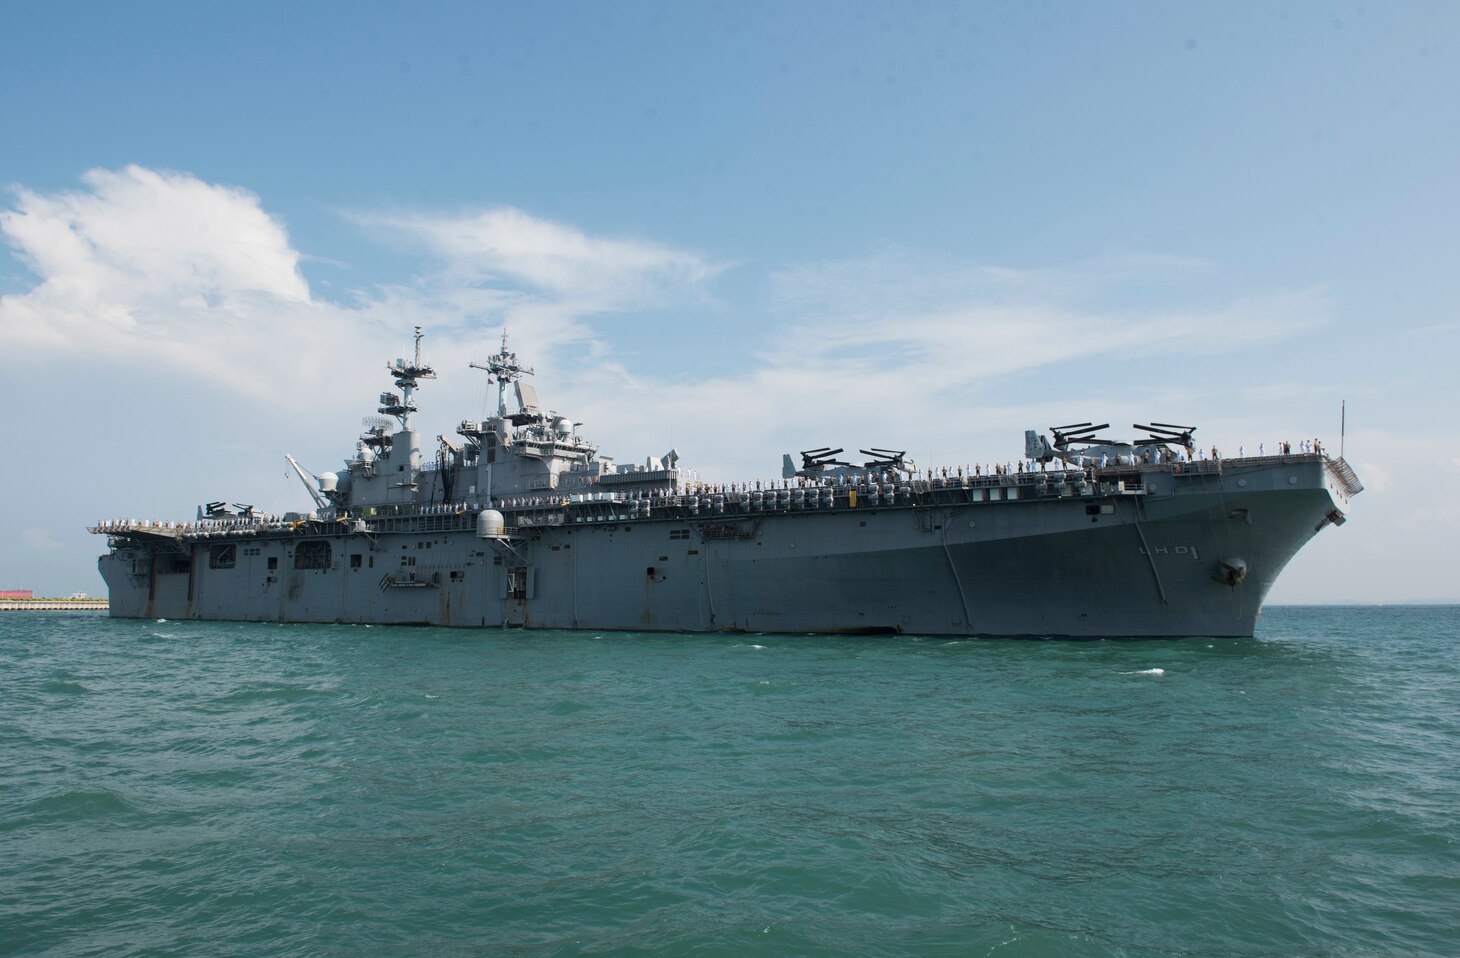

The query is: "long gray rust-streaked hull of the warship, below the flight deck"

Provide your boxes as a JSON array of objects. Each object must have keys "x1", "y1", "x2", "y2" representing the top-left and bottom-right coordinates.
[{"x1": 99, "y1": 456, "x2": 1361, "y2": 637}]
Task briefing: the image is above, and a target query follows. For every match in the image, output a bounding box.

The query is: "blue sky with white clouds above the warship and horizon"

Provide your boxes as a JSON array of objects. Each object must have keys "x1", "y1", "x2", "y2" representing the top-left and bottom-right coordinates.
[{"x1": 0, "y1": 3, "x2": 1460, "y2": 602}]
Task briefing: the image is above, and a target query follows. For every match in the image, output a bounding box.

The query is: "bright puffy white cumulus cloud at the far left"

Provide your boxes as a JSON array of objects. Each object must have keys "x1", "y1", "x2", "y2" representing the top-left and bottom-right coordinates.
[{"x1": 0, "y1": 166, "x2": 353, "y2": 390}]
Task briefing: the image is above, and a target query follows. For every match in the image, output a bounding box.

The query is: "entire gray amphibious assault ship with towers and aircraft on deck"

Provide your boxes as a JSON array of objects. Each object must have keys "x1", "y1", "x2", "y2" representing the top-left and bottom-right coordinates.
[{"x1": 91, "y1": 327, "x2": 1362, "y2": 637}]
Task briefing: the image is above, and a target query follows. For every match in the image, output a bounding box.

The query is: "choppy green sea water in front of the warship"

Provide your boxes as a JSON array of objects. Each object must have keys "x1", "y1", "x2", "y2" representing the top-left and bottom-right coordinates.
[{"x1": 0, "y1": 608, "x2": 1460, "y2": 957}]
